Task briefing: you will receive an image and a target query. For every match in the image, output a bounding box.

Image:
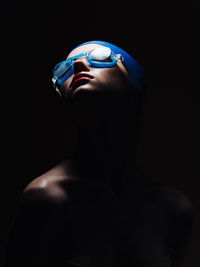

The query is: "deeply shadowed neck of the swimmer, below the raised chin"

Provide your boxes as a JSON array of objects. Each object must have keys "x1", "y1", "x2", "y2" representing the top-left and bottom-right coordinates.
[{"x1": 63, "y1": 92, "x2": 136, "y2": 193}]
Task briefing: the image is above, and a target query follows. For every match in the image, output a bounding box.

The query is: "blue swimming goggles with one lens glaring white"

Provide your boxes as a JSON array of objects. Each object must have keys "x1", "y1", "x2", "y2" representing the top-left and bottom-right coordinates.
[{"x1": 52, "y1": 47, "x2": 123, "y2": 88}]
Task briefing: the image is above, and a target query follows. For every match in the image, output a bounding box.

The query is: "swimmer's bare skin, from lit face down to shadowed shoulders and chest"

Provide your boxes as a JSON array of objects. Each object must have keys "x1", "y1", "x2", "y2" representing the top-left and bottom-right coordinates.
[{"x1": 5, "y1": 45, "x2": 193, "y2": 267}]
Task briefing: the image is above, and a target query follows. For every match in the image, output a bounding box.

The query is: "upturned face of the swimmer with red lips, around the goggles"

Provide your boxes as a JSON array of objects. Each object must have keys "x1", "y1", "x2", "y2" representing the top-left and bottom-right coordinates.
[{"x1": 61, "y1": 44, "x2": 130, "y2": 100}]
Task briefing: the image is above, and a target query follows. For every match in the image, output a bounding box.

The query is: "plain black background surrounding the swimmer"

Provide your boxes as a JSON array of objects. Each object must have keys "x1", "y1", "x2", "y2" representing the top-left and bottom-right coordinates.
[{"x1": 0, "y1": 1, "x2": 200, "y2": 267}]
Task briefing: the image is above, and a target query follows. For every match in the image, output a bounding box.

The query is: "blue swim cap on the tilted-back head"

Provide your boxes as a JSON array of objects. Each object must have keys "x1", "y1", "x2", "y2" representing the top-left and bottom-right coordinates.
[{"x1": 71, "y1": 41, "x2": 147, "y2": 96}]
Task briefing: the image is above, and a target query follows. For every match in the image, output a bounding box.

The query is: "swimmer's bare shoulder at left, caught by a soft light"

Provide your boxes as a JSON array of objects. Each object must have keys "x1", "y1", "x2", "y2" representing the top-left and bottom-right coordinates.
[{"x1": 22, "y1": 162, "x2": 94, "y2": 208}]
